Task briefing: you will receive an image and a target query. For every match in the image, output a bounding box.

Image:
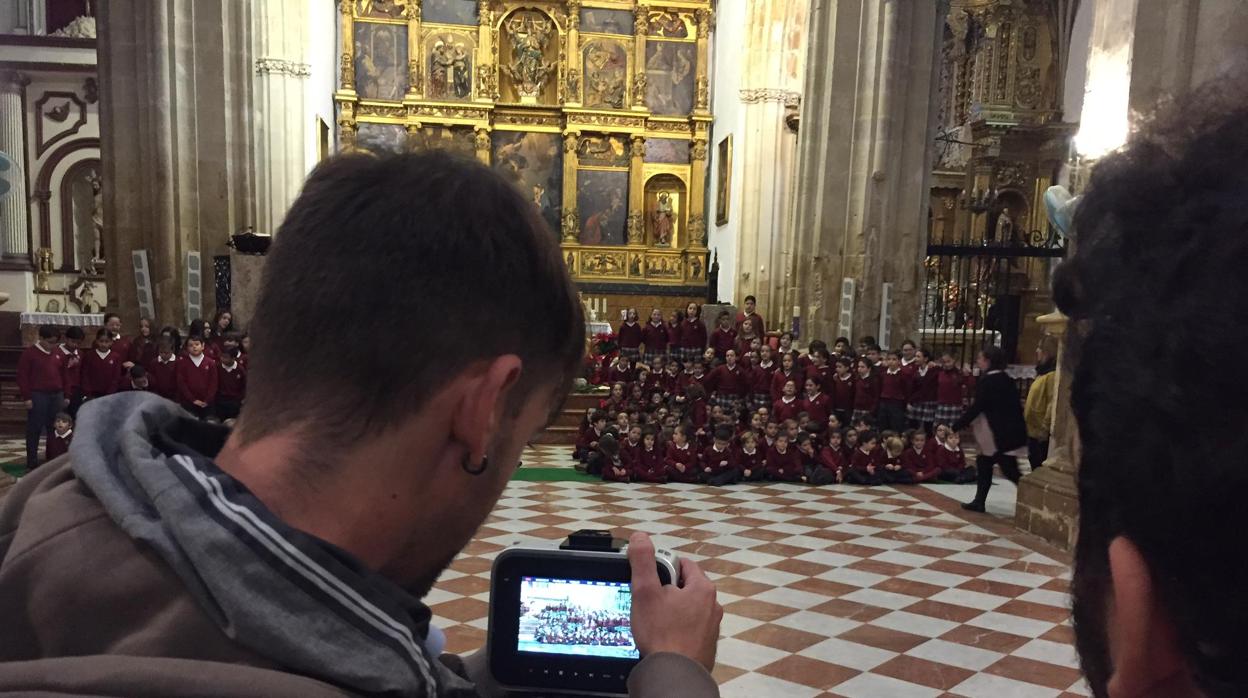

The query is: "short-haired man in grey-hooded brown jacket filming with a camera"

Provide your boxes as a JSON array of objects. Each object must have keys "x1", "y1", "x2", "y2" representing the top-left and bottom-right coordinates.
[{"x1": 0, "y1": 152, "x2": 723, "y2": 698}]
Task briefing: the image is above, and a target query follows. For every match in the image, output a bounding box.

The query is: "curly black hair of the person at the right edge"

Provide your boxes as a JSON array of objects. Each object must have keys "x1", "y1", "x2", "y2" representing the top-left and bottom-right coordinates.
[{"x1": 1053, "y1": 84, "x2": 1248, "y2": 696}]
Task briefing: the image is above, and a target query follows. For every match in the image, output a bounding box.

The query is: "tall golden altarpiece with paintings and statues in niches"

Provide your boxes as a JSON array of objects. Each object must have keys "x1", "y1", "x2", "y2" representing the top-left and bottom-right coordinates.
[{"x1": 334, "y1": 0, "x2": 711, "y2": 288}]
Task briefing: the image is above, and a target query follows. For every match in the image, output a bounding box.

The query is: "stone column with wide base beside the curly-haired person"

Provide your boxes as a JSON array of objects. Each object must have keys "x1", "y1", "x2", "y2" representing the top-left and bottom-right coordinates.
[{"x1": 1015, "y1": 312, "x2": 1080, "y2": 549}]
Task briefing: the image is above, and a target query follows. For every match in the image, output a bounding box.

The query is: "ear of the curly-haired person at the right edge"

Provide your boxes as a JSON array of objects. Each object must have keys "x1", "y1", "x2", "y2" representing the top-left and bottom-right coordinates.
[{"x1": 1106, "y1": 536, "x2": 1187, "y2": 698}]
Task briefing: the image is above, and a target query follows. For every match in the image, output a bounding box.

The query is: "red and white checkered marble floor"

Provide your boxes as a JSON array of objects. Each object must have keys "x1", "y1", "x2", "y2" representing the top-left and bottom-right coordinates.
[{"x1": 0, "y1": 440, "x2": 1088, "y2": 698}]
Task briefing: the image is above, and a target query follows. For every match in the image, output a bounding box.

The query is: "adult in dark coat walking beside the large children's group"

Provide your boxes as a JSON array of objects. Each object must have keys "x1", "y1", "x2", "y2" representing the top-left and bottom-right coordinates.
[{"x1": 953, "y1": 347, "x2": 1027, "y2": 512}]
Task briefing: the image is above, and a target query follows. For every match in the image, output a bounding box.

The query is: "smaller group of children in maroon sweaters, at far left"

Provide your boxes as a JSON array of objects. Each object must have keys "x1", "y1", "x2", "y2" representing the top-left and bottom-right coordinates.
[{"x1": 17, "y1": 311, "x2": 248, "y2": 468}]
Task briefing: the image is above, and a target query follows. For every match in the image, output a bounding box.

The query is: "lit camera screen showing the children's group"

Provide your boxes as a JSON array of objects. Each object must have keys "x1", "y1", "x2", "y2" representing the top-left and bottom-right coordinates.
[{"x1": 515, "y1": 577, "x2": 640, "y2": 659}]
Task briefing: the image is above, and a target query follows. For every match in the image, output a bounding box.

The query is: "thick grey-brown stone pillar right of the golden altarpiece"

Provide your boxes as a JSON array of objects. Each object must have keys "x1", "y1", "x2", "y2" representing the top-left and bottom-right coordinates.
[{"x1": 782, "y1": 0, "x2": 947, "y2": 343}]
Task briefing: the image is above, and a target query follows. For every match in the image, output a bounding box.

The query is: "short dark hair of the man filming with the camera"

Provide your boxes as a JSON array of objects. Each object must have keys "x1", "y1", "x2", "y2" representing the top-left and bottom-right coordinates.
[{"x1": 238, "y1": 151, "x2": 585, "y2": 454}]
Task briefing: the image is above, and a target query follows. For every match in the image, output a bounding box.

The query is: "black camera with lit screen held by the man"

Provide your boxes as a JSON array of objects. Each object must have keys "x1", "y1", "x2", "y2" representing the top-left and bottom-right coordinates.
[{"x1": 487, "y1": 529, "x2": 680, "y2": 696}]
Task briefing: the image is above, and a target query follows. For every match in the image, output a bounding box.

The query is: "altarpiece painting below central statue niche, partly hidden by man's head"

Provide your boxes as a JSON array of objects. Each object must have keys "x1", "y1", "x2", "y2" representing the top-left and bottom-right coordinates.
[{"x1": 490, "y1": 131, "x2": 564, "y2": 231}]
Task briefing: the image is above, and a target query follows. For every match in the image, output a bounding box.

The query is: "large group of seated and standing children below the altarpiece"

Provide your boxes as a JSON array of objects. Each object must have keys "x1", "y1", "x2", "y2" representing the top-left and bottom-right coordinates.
[{"x1": 574, "y1": 297, "x2": 975, "y2": 486}]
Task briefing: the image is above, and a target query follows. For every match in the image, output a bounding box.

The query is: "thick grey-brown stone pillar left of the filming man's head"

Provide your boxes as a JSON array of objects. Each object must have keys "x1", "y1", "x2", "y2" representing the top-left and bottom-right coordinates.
[{"x1": 99, "y1": 0, "x2": 255, "y2": 327}]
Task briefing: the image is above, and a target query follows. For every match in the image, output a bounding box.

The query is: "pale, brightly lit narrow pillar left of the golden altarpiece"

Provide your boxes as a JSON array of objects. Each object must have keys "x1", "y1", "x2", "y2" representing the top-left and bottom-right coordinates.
[{"x1": 253, "y1": 0, "x2": 309, "y2": 233}]
